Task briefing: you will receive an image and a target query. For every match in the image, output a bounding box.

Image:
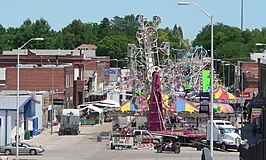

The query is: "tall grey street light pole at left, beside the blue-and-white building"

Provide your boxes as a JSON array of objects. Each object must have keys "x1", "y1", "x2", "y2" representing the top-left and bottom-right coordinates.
[{"x1": 15, "y1": 38, "x2": 44, "y2": 160}]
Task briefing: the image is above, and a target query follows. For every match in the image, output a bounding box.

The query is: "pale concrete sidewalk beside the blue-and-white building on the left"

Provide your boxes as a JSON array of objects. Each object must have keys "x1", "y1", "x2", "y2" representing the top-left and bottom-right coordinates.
[{"x1": 23, "y1": 125, "x2": 60, "y2": 147}]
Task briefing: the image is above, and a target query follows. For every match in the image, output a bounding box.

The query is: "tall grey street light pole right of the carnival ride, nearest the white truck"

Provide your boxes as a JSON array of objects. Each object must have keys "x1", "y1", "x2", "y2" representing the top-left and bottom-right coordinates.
[{"x1": 178, "y1": 2, "x2": 214, "y2": 157}]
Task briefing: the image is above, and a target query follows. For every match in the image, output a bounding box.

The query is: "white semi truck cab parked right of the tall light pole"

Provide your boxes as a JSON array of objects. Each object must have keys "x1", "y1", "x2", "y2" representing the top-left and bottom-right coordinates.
[{"x1": 207, "y1": 120, "x2": 244, "y2": 151}]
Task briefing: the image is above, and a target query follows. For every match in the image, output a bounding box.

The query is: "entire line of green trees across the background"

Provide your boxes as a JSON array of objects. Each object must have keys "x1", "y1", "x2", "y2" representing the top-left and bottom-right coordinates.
[{"x1": 0, "y1": 15, "x2": 266, "y2": 63}]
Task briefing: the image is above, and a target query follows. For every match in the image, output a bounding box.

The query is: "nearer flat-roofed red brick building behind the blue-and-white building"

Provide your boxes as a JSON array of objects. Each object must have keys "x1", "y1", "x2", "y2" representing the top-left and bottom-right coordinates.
[{"x1": 4, "y1": 65, "x2": 75, "y2": 108}]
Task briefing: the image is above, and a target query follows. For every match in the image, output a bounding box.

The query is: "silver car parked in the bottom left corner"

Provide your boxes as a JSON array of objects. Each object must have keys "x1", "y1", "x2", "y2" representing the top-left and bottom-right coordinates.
[{"x1": 0, "y1": 142, "x2": 45, "y2": 155}]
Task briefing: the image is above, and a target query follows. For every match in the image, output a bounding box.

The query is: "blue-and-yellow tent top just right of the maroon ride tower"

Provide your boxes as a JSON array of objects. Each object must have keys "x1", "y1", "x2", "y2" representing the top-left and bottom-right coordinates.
[{"x1": 174, "y1": 97, "x2": 199, "y2": 112}]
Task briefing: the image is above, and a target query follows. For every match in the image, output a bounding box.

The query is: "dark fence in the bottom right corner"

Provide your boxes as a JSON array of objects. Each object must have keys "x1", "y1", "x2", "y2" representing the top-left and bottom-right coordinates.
[{"x1": 239, "y1": 139, "x2": 266, "y2": 160}]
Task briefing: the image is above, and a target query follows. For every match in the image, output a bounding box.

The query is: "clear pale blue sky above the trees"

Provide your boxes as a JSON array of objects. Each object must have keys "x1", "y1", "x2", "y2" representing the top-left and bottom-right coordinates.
[{"x1": 0, "y1": 0, "x2": 266, "y2": 40}]
